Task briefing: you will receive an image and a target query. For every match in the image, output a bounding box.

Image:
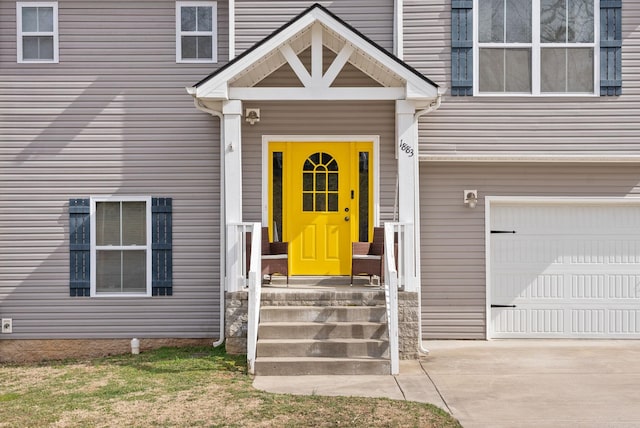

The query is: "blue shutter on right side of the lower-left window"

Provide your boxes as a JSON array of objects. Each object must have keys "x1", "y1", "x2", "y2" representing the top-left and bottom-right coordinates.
[{"x1": 151, "y1": 198, "x2": 173, "y2": 296}]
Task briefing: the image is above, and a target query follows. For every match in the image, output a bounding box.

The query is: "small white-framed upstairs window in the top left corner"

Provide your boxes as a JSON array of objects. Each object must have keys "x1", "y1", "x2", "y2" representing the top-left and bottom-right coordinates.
[{"x1": 16, "y1": 2, "x2": 58, "y2": 63}]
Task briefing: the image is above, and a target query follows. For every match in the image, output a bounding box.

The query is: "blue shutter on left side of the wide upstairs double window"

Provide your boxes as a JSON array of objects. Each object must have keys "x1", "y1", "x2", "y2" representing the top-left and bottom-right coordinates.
[{"x1": 451, "y1": 0, "x2": 473, "y2": 95}]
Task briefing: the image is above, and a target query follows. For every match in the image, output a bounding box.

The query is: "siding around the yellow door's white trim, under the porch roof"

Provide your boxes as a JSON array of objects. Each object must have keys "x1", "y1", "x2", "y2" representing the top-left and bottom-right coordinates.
[{"x1": 242, "y1": 101, "x2": 397, "y2": 221}]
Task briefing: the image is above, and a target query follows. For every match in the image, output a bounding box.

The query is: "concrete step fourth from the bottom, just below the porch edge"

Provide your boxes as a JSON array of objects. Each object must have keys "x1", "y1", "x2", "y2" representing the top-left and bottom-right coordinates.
[{"x1": 260, "y1": 306, "x2": 387, "y2": 323}]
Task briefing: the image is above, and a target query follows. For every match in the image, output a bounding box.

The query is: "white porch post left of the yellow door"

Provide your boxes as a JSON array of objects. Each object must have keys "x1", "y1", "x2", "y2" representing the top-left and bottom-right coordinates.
[{"x1": 222, "y1": 100, "x2": 244, "y2": 291}]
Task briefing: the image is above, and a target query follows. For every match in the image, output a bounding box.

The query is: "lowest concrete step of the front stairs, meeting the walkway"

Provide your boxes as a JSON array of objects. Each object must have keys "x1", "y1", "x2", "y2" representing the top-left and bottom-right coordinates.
[{"x1": 255, "y1": 357, "x2": 391, "y2": 376}]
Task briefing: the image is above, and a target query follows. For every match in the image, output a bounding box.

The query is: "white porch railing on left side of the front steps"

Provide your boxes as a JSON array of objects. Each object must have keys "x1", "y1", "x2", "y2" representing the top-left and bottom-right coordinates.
[{"x1": 227, "y1": 223, "x2": 262, "y2": 374}]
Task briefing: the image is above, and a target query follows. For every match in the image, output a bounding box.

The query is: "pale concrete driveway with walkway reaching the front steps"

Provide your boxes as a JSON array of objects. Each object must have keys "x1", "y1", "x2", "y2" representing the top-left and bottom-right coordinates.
[{"x1": 254, "y1": 340, "x2": 640, "y2": 428}]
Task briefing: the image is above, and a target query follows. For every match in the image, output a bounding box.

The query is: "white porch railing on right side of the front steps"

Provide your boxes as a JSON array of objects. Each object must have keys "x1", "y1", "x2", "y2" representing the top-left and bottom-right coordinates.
[{"x1": 384, "y1": 222, "x2": 414, "y2": 375}]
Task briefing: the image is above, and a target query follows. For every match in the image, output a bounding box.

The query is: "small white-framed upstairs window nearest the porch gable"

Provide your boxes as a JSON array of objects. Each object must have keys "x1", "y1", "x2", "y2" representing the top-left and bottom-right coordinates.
[{"x1": 176, "y1": 1, "x2": 218, "y2": 63}]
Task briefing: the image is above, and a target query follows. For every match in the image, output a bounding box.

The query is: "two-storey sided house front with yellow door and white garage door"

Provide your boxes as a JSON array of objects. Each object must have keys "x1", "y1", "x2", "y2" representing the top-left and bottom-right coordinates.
[{"x1": 0, "y1": 0, "x2": 640, "y2": 360}]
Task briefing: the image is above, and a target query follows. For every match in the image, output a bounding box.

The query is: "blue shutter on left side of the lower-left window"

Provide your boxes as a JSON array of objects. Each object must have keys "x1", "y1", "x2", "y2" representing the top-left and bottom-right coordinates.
[{"x1": 69, "y1": 199, "x2": 91, "y2": 297}]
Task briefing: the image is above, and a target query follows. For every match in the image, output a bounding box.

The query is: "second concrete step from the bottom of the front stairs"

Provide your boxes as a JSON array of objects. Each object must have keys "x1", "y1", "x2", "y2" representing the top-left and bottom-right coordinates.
[{"x1": 256, "y1": 339, "x2": 389, "y2": 358}]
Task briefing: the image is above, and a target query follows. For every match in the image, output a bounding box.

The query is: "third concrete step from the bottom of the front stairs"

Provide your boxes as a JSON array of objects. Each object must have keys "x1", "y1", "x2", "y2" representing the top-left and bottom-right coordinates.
[{"x1": 258, "y1": 322, "x2": 388, "y2": 339}]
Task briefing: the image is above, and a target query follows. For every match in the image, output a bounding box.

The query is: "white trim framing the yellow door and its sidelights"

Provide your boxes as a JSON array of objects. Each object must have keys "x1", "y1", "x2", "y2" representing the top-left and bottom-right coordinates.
[{"x1": 261, "y1": 135, "x2": 380, "y2": 234}]
